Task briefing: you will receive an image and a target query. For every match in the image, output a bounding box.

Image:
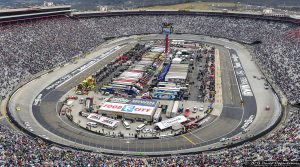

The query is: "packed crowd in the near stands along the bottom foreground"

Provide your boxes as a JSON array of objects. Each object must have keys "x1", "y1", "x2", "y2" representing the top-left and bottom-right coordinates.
[{"x1": 0, "y1": 108, "x2": 300, "y2": 167}]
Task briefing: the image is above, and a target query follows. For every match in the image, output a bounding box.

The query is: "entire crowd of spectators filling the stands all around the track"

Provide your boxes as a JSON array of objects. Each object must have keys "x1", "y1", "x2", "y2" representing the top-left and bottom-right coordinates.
[{"x1": 0, "y1": 15, "x2": 300, "y2": 166}]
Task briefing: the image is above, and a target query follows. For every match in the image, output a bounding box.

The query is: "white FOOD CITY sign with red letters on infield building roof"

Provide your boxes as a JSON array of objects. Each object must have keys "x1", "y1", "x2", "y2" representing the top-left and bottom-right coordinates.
[{"x1": 100, "y1": 102, "x2": 154, "y2": 115}]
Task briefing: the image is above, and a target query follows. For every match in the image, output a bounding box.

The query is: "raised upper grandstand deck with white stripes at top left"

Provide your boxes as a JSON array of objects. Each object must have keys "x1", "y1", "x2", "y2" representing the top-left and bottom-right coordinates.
[{"x1": 0, "y1": 6, "x2": 71, "y2": 23}]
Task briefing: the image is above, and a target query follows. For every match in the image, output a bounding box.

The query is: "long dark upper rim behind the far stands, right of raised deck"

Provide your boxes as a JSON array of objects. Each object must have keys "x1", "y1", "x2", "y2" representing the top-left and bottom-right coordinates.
[{"x1": 72, "y1": 10, "x2": 299, "y2": 23}]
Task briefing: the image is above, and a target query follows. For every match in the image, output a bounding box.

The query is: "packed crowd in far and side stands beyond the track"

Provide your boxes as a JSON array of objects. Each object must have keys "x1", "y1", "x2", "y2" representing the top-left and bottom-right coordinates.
[{"x1": 0, "y1": 16, "x2": 300, "y2": 103}]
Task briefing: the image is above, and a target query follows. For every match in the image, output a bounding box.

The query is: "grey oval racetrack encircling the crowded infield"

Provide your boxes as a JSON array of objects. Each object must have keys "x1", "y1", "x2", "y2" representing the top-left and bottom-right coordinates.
[{"x1": 9, "y1": 34, "x2": 280, "y2": 155}]
